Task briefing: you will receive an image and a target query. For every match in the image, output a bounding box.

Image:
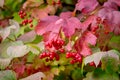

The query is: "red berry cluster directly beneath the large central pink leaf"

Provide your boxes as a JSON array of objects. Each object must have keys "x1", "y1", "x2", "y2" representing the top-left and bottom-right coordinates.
[{"x1": 46, "y1": 39, "x2": 64, "y2": 50}]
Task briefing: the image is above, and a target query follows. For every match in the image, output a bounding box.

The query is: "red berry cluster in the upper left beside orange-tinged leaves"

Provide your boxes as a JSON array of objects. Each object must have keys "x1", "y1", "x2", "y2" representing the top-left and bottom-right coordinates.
[{"x1": 18, "y1": 10, "x2": 33, "y2": 27}]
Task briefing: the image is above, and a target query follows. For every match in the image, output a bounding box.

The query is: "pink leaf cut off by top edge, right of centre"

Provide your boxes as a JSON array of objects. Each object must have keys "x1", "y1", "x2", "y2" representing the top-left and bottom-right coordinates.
[{"x1": 76, "y1": 0, "x2": 99, "y2": 13}]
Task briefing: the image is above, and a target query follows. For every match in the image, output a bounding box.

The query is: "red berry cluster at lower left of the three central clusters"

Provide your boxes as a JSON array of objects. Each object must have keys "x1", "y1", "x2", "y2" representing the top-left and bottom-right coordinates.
[{"x1": 39, "y1": 52, "x2": 59, "y2": 62}]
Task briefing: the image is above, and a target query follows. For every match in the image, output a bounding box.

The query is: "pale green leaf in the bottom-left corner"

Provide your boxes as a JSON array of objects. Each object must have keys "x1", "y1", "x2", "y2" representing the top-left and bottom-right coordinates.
[{"x1": 0, "y1": 70, "x2": 17, "y2": 80}]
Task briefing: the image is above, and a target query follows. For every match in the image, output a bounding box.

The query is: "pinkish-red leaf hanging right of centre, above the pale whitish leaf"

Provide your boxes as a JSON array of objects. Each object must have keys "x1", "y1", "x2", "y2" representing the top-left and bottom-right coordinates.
[{"x1": 75, "y1": 32, "x2": 97, "y2": 57}]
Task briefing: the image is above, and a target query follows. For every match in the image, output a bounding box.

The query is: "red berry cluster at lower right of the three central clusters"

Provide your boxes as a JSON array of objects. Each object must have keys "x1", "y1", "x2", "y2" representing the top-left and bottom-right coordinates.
[{"x1": 66, "y1": 52, "x2": 82, "y2": 64}]
